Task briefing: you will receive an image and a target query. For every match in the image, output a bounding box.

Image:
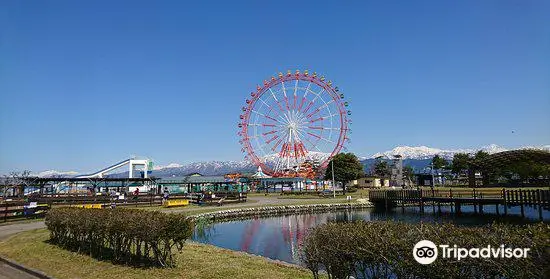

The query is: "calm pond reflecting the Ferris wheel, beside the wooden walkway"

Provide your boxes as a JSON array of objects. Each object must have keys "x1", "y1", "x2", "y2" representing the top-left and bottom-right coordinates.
[{"x1": 194, "y1": 206, "x2": 550, "y2": 264}]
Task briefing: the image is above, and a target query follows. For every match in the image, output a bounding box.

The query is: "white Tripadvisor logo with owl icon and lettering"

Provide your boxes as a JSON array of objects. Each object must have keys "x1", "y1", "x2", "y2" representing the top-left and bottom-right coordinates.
[{"x1": 413, "y1": 240, "x2": 531, "y2": 264}]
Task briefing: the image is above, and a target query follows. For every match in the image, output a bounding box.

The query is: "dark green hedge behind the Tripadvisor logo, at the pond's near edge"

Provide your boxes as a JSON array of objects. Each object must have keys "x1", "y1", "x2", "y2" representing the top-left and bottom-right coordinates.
[{"x1": 301, "y1": 221, "x2": 550, "y2": 278}]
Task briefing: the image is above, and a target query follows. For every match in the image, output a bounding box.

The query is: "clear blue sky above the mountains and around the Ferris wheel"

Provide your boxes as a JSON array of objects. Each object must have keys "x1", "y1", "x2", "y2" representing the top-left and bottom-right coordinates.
[{"x1": 0, "y1": 0, "x2": 550, "y2": 173}]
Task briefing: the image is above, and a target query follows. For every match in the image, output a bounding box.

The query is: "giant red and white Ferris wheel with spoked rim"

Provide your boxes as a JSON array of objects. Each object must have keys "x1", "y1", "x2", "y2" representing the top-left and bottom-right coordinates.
[{"x1": 238, "y1": 70, "x2": 351, "y2": 176}]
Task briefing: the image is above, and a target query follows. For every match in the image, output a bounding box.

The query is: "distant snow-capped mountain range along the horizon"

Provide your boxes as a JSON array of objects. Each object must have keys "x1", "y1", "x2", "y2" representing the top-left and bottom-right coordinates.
[{"x1": 34, "y1": 144, "x2": 550, "y2": 177}]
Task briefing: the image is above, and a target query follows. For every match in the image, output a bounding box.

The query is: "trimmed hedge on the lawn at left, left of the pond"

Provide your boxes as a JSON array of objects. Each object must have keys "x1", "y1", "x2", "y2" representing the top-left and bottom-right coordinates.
[{"x1": 46, "y1": 208, "x2": 194, "y2": 267}]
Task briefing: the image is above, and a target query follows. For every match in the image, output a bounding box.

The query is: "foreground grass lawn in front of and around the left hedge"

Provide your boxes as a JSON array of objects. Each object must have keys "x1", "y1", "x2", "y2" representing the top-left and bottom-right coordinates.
[{"x1": 0, "y1": 229, "x2": 312, "y2": 279}]
